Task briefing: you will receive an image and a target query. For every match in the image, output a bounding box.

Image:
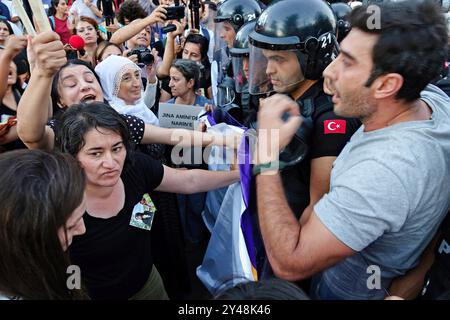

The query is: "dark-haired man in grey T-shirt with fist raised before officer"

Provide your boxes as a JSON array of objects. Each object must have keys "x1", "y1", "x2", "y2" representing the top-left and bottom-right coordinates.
[{"x1": 254, "y1": 1, "x2": 450, "y2": 299}]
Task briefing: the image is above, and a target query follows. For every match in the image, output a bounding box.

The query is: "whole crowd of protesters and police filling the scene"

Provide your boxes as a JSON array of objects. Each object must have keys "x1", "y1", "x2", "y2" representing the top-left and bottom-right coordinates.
[{"x1": 0, "y1": 0, "x2": 450, "y2": 300}]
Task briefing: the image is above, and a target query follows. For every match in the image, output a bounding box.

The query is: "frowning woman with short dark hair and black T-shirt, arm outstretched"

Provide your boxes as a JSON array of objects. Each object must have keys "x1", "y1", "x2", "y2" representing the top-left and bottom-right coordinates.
[{"x1": 56, "y1": 102, "x2": 239, "y2": 299}]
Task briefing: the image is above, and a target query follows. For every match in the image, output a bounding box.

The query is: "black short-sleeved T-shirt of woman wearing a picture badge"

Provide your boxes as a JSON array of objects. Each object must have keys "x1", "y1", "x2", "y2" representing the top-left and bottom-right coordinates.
[{"x1": 69, "y1": 152, "x2": 164, "y2": 299}]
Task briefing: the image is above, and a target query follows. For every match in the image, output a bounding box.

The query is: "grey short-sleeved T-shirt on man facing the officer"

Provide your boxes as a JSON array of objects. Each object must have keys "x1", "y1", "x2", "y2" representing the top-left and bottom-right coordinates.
[{"x1": 314, "y1": 86, "x2": 450, "y2": 299}]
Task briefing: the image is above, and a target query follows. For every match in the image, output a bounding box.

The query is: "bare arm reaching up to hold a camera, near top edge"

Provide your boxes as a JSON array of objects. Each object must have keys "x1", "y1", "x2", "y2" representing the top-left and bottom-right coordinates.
[{"x1": 110, "y1": 6, "x2": 167, "y2": 45}]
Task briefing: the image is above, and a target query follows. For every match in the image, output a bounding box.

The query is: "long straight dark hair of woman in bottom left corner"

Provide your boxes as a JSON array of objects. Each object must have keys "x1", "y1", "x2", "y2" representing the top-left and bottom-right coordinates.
[{"x1": 0, "y1": 150, "x2": 86, "y2": 299}]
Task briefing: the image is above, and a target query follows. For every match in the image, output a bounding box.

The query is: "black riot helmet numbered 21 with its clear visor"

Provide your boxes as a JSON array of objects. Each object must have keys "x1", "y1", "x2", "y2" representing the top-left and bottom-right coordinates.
[{"x1": 249, "y1": 0, "x2": 336, "y2": 94}]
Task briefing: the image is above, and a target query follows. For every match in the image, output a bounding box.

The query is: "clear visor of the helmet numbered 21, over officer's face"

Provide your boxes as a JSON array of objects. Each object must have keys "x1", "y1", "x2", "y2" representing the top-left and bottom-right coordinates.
[{"x1": 248, "y1": 43, "x2": 305, "y2": 95}]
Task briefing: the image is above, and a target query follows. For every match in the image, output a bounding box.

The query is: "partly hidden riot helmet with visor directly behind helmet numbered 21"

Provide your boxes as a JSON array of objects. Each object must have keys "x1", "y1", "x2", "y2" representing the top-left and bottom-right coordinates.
[{"x1": 230, "y1": 20, "x2": 256, "y2": 93}]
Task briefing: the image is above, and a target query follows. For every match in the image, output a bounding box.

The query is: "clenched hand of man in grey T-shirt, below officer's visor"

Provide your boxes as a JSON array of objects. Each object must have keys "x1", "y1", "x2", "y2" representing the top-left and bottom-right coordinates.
[{"x1": 256, "y1": 94, "x2": 302, "y2": 163}]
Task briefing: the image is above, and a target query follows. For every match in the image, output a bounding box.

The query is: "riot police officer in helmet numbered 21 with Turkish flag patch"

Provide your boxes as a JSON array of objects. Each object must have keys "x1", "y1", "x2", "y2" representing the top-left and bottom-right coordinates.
[{"x1": 249, "y1": 0, "x2": 360, "y2": 222}]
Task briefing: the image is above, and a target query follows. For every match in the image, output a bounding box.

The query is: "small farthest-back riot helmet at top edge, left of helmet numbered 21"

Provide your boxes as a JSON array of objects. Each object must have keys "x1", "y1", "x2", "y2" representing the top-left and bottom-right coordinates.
[{"x1": 214, "y1": 0, "x2": 262, "y2": 32}]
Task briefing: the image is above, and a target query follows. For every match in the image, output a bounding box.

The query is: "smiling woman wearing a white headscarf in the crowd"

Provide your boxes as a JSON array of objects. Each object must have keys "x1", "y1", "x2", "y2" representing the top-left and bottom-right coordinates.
[{"x1": 95, "y1": 55, "x2": 159, "y2": 125}]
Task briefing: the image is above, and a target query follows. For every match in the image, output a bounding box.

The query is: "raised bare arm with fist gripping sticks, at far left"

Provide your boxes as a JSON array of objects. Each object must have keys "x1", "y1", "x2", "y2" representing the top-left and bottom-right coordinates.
[{"x1": 17, "y1": 32, "x2": 67, "y2": 150}]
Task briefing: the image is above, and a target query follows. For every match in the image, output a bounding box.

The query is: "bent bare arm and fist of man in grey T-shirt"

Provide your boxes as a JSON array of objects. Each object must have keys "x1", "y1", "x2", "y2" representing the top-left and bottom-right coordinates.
[{"x1": 256, "y1": 95, "x2": 354, "y2": 281}]
